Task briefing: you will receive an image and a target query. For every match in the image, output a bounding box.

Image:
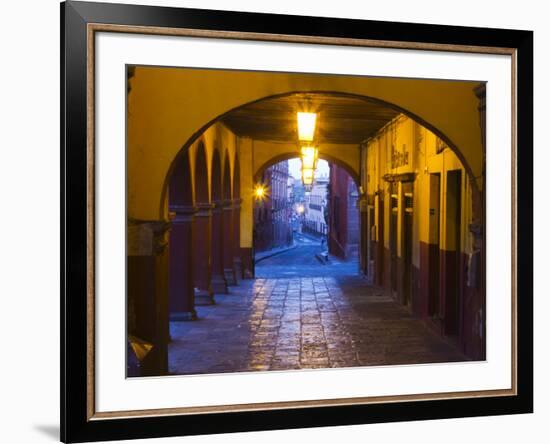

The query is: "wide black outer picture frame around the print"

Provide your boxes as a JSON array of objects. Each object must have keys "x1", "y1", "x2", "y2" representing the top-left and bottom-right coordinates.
[{"x1": 60, "y1": 2, "x2": 533, "y2": 442}]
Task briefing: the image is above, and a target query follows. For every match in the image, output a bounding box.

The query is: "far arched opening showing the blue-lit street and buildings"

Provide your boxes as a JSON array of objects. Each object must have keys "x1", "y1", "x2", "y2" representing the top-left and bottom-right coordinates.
[{"x1": 254, "y1": 157, "x2": 361, "y2": 278}]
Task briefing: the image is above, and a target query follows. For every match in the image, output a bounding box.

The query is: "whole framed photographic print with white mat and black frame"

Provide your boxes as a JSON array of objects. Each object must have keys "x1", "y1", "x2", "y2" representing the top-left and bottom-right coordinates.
[{"x1": 61, "y1": 2, "x2": 533, "y2": 442}]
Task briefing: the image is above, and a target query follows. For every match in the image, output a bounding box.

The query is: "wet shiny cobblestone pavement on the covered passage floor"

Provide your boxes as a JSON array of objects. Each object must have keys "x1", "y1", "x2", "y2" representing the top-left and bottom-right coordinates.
[{"x1": 169, "y1": 275, "x2": 466, "y2": 374}]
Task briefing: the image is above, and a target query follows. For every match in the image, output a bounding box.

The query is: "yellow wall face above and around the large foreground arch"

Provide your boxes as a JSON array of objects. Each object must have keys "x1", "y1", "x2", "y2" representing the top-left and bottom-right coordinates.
[{"x1": 127, "y1": 67, "x2": 482, "y2": 220}]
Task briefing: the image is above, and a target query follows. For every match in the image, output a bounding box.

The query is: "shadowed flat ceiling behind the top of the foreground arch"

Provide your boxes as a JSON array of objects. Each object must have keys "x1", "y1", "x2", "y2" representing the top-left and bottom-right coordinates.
[{"x1": 223, "y1": 93, "x2": 399, "y2": 144}]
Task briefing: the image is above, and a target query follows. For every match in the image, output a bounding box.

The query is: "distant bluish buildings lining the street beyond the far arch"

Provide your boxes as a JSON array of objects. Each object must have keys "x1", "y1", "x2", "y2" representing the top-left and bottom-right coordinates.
[{"x1": 254, "y1": 161, "x2": 360, "y2": 259}]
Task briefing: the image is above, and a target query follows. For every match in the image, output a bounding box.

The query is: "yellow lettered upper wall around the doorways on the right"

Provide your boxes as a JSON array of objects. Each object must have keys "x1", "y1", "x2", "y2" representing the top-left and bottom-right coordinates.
[{"x1": 362, "y1": 115, "x2": 473, "y2": 266}]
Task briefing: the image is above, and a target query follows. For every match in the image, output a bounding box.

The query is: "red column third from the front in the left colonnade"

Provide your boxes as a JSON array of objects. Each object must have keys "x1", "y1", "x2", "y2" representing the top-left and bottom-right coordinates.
[{"x1": 193, "y1": 203, "x2": 215, "y2": 305}]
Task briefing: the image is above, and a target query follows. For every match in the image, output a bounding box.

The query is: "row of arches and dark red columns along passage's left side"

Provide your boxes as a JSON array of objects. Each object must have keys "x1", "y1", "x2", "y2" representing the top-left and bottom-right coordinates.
[{"x1": 167, "y1": 140, "x2": 244, "y2": 321}]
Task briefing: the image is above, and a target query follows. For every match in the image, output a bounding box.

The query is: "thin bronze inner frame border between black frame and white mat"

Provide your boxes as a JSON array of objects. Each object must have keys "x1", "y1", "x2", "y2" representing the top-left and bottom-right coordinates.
[{"x1": 86, "y1": 23, "x2": 518, "y2": 421}]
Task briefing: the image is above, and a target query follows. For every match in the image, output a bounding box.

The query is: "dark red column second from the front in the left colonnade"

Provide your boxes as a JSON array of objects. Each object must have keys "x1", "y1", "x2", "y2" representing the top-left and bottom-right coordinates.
[{"x1": 169, "y1": 206, "x2": 201, "y2": 321}]
